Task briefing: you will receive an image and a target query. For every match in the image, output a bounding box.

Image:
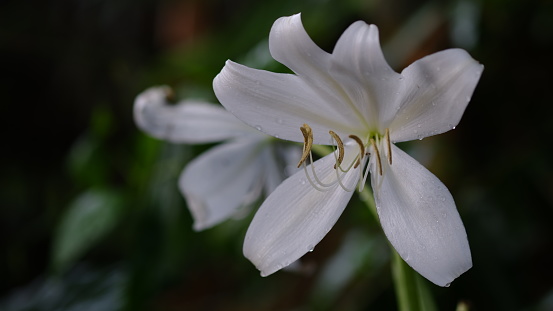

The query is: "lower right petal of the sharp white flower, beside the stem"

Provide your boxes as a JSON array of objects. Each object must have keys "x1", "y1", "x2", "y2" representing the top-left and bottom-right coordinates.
[{"x1": 371, "y1": 145, "x2": 472, "y2": 286}]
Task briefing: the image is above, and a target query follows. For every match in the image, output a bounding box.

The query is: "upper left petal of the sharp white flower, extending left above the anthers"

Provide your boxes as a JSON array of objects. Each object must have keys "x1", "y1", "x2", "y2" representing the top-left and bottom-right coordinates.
[{"x1": 213, "y1": 61, "x2": 356, "y2": 144}]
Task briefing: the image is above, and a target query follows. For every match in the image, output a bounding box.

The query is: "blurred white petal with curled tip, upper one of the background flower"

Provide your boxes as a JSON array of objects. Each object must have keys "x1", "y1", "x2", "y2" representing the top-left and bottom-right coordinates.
[{"x1": 134, "y1": 87, "x2": 259, "y2": 143}]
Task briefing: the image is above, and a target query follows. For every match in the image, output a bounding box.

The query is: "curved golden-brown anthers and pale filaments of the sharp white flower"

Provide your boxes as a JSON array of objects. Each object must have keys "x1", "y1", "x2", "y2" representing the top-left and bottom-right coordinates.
[{"x1": 298, "y1": 124, "x2": 392, "y2": 191}]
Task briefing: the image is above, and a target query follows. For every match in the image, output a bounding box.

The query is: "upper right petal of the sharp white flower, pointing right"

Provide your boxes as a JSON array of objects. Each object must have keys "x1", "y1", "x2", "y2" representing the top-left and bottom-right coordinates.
[{"x1": 389, "y1": 49, "x2": 484, "y2": 142}]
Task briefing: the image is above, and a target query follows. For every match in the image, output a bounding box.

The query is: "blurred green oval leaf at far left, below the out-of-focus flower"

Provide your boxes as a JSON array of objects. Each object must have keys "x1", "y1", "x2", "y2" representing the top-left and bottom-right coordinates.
[{"x1": 52, "y1": 190, "x2": 123, "y2": 271}]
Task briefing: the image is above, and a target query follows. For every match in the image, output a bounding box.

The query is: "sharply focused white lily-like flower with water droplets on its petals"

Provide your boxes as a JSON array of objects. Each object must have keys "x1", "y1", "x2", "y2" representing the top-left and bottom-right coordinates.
[{"x1": 213, "y1": 14, "x2": 483, "y2": 286}]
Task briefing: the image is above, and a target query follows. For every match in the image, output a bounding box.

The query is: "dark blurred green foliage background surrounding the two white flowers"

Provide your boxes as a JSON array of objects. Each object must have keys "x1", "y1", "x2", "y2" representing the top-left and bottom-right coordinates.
[{"x1": 0, "y1": 0, "x2": 553, "y2": 310}]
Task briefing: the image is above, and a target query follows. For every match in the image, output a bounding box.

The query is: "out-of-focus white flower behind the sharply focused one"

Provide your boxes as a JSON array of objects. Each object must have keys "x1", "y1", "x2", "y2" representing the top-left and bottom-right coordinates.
[{"x1": 134, "y1": 87, "x2": 301, "y2": 230}]
